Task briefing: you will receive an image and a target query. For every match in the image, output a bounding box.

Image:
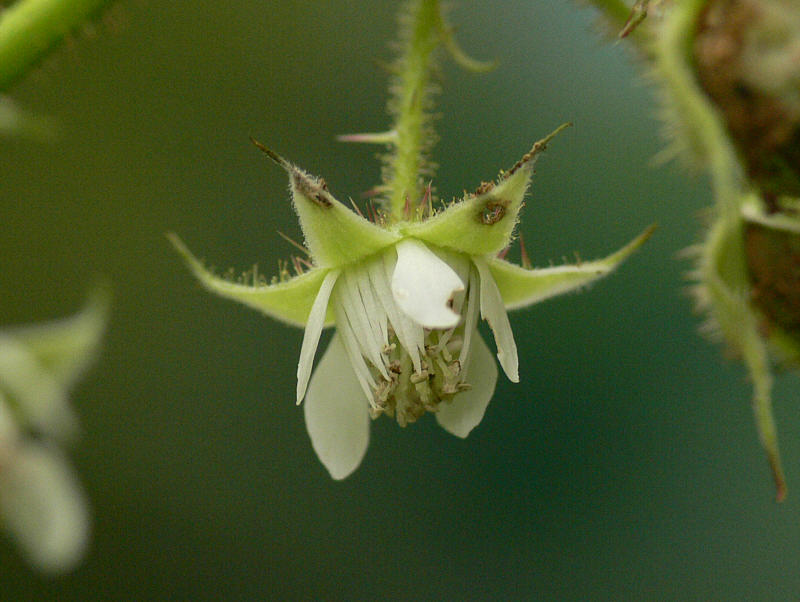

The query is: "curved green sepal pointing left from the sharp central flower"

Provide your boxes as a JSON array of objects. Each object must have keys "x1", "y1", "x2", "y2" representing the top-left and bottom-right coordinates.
[{"x1": 167, "y1": 233, "x2": 333, "y2": 327}]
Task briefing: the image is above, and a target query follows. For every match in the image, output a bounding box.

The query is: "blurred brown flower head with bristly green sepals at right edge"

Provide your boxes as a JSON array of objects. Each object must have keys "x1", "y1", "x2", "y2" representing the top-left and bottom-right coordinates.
[{"x1": 592, "y1": 0, "x2": 800, "y2": 500}]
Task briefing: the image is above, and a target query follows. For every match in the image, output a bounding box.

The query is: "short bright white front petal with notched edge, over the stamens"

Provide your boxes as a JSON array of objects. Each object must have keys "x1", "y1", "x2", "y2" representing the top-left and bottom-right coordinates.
[{"x1": 392, "y1": 239, "x2": 464, "y2": 330}]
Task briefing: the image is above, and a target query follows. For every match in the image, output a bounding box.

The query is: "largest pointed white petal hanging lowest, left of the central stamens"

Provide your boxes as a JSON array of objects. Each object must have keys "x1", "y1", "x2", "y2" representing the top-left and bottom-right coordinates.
[{"x1": 305, "y1": 334, "x2": 369, "y2": 479}]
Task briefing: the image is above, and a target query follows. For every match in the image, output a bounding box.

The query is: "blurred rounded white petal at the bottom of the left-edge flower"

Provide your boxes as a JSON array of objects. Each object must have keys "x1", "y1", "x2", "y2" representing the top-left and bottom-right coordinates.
[{"x1": 0, "y1": 443, "x2": 89, "y2": 572}]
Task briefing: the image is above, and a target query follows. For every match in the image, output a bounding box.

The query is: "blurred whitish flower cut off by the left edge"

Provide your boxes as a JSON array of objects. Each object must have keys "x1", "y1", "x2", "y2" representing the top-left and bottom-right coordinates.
[{"x1": 0, "y1": 292, "x2": 107, "y2": 572}]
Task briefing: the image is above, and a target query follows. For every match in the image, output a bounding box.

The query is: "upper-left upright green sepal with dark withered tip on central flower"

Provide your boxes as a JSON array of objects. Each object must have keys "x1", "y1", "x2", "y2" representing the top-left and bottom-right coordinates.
[{"x1": 253, "y1": 140, "x2": 399, "y2": 268}]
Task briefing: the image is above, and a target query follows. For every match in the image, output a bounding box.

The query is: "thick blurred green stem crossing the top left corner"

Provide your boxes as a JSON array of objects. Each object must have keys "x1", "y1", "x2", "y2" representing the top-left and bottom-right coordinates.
[{"x1": 0, "y1": 0, "x2": 108, "y2": 92}]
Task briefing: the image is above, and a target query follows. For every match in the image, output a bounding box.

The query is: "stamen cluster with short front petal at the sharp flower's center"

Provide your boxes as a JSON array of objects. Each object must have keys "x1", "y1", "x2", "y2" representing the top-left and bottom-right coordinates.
[{"x1": 333, "y1": 243, "x2": 479, "y2": 426}]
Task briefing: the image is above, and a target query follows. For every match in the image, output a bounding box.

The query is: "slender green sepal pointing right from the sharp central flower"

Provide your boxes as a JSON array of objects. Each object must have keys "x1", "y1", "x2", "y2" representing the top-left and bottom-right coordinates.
[{"x1": 488, "y1": 226, "x2": 655, "y2": 309}]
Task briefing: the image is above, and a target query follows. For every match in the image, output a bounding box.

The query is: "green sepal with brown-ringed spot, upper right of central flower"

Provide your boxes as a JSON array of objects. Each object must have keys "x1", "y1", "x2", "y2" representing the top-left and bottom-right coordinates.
[{"x1": 399, "y1": 124, "x2": 569, "y2": 255}]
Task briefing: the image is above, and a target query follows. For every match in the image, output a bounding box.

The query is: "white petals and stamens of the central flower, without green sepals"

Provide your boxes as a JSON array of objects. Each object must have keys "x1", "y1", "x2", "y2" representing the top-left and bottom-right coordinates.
[{"x1": 298, "y1": 239, "x2": 518, "y2": 479}]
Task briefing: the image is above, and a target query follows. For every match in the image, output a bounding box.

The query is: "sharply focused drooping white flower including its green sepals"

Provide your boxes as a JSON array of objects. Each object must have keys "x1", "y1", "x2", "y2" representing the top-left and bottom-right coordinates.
[{"x1": 170, "y1": 129, "x2": 652, "y2": 479}]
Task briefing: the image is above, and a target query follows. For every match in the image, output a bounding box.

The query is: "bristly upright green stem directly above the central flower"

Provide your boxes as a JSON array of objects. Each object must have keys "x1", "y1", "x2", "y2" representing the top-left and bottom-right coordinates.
[{"x1": 385, "y1": 0, "x2": 442, "y2": 221}]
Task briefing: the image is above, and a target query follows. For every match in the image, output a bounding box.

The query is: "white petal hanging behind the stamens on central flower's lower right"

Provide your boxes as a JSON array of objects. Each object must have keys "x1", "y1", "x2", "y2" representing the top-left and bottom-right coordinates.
[{"x1": 436, "y1": 336, "x2": 497, "y2": 439}]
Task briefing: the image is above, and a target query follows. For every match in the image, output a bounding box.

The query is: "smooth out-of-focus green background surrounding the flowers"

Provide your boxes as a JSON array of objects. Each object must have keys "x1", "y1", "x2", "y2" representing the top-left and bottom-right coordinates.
[{"x1": 0, "y1": 0, "x2": 800, "y2": 600}]
